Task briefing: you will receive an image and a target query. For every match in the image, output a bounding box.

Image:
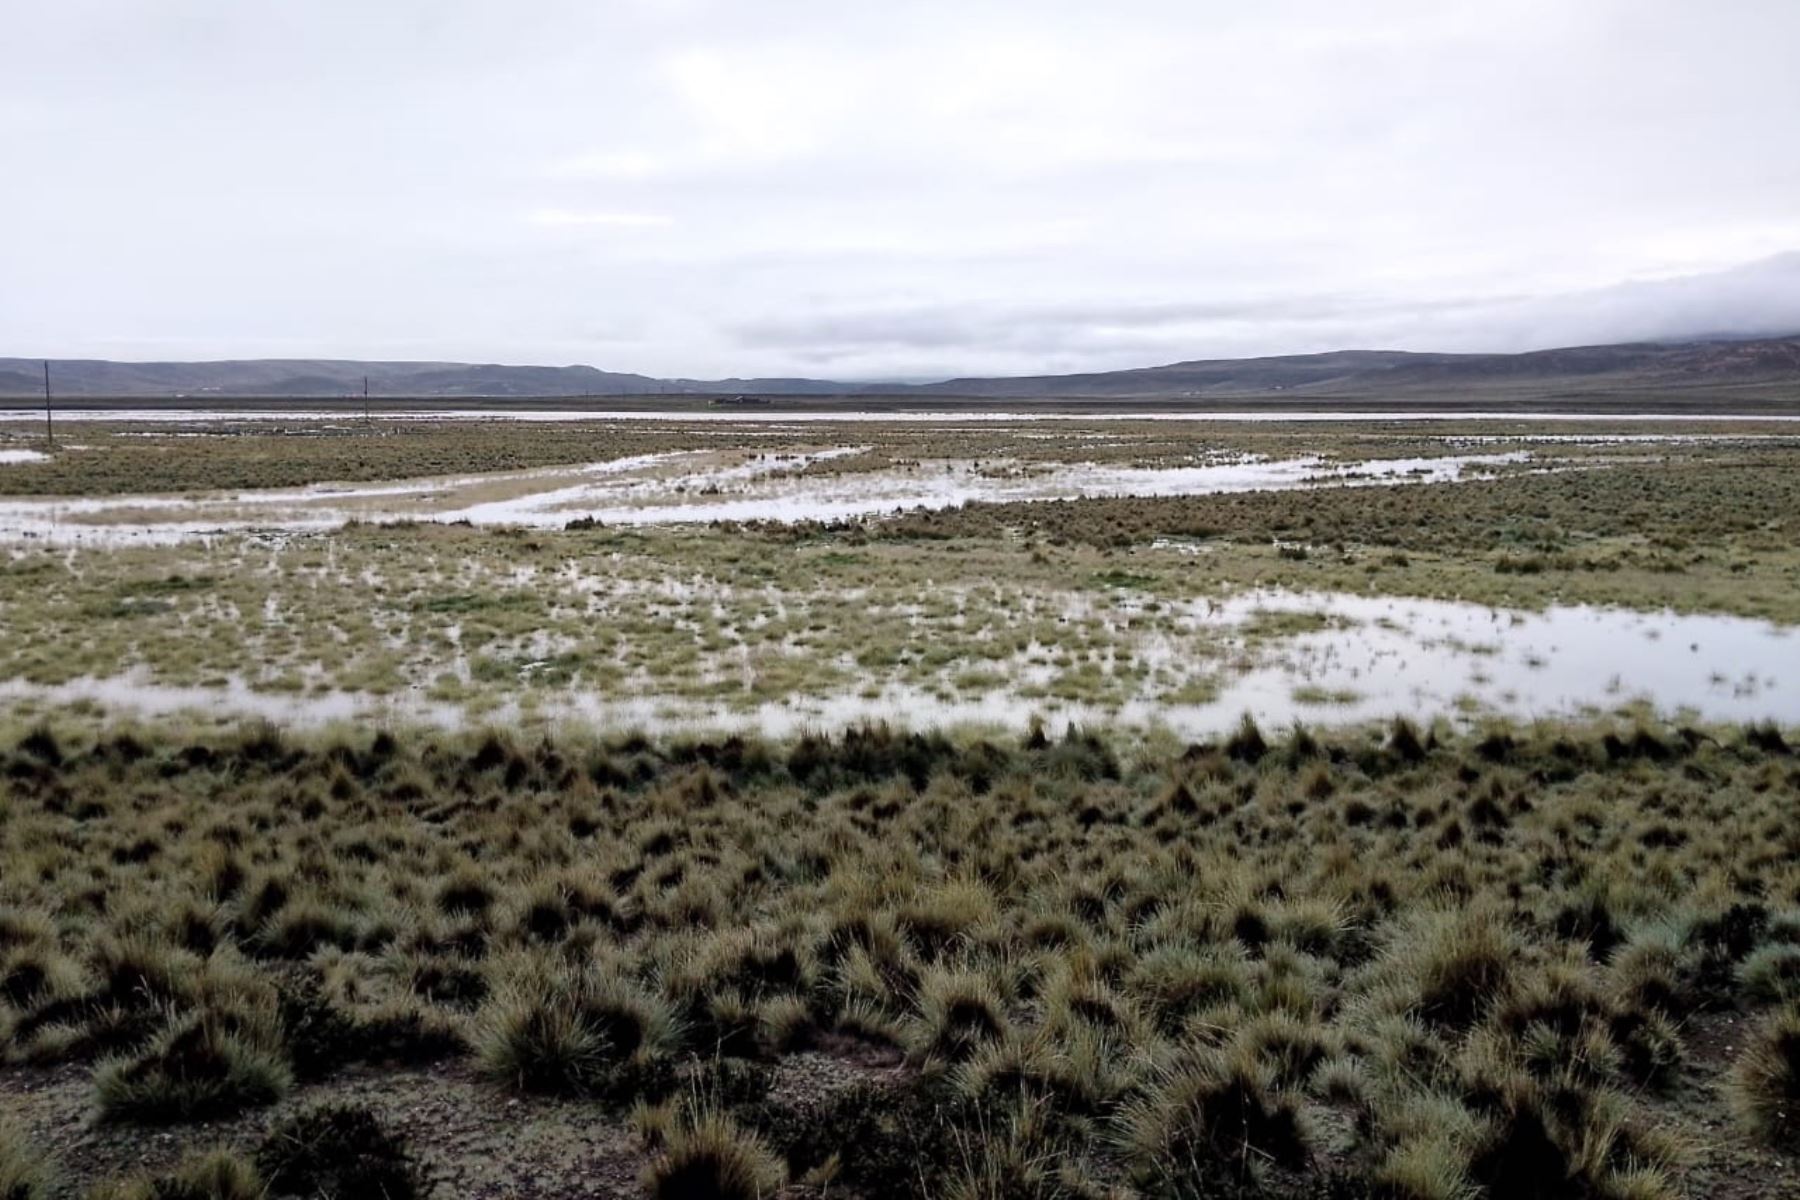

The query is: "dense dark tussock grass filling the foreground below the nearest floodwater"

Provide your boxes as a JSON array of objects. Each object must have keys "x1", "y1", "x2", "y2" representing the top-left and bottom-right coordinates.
[{"x1": 0, "y1": 716, "x2": 1800, "y2": 1200}]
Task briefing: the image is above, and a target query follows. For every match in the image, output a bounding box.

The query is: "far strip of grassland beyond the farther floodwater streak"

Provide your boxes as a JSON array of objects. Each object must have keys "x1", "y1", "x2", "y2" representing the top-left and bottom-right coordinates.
[{"x1": 0, "y1": 412, "x2": 1796, "y2": 497}]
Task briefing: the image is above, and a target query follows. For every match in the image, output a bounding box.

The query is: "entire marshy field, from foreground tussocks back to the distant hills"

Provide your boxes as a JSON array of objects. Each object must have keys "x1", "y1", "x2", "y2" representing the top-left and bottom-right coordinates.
[{"x1": 0, "y1": 408, "x2": 1800, "y2": 1200}]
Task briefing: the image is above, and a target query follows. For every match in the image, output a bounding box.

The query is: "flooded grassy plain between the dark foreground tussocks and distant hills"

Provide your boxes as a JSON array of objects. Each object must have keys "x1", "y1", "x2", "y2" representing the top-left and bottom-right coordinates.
[{"x1": 0, "y1": 410, "x2": 1800, "y2": 738}]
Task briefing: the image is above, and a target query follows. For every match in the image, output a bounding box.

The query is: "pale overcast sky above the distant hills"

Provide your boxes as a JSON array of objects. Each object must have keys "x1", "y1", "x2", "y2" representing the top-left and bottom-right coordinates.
[{"x1": 0, "y1": 0, "x2": 1800, "y2": 378}]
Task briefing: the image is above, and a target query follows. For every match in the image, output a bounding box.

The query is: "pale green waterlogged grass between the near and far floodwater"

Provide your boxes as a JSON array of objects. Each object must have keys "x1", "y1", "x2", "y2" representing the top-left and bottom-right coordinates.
[{"x1": 0, "y1": 426, "x2": 1800, "y2": 727}]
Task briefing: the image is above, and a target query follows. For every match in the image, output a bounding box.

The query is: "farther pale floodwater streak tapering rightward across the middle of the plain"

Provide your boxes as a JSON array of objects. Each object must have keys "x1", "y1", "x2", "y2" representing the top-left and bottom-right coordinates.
[{"x1": 0, "y1": 446, "x2": 1532, "y2": 543}]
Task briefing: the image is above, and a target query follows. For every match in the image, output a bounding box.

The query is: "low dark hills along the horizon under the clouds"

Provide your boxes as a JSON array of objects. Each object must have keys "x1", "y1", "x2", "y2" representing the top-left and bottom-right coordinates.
[{"x1": 0, "y1": 336, "x2": 1800, "y2": 399}]
